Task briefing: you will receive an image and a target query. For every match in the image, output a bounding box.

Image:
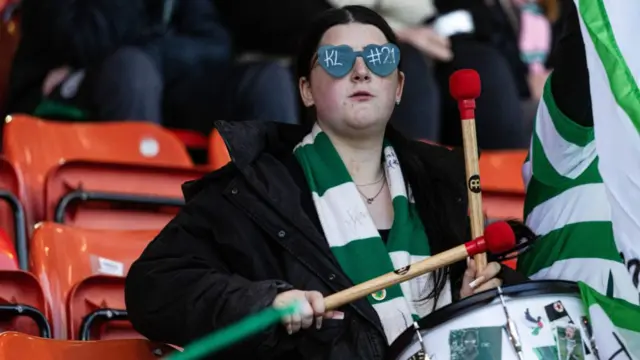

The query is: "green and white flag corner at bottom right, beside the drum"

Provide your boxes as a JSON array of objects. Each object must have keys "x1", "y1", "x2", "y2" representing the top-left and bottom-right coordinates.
[{"x1": 579, "y1": 282, "x2": 640, "y2": 360}]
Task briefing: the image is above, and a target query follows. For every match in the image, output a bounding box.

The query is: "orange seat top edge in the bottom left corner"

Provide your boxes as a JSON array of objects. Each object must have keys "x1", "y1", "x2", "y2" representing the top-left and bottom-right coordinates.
[{"x1": 0, "y1": 332, "x2": 175, "y2": 360}]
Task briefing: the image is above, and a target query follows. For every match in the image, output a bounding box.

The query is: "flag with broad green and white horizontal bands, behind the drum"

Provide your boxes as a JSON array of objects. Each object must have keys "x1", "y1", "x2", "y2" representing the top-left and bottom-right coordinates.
[{"x1": 518, "y1": 0, "x2": 640, "y2": 304}]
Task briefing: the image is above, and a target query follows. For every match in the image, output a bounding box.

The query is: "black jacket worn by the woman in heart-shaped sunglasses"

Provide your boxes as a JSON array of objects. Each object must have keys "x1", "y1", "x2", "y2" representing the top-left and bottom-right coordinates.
[{"x1": 126, "y1": 123, "x2": 521, "y2": 360}]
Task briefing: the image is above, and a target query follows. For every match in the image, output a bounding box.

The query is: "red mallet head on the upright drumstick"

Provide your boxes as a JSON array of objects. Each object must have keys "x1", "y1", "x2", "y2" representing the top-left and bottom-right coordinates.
[{"x1": 449, "y1": 69, "x2": 481, "y2": 120}]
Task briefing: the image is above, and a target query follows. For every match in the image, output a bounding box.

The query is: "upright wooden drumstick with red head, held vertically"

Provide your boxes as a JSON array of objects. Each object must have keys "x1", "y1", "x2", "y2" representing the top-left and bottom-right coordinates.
[{"x1": 449, "y1": 69, "x2": 487, "y2": 271}]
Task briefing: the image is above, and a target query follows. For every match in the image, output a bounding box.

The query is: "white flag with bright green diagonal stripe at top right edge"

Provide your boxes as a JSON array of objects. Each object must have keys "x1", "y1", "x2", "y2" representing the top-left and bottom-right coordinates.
[{"x1": 575, "y1": 0, "x2": 640, "y2": 289}]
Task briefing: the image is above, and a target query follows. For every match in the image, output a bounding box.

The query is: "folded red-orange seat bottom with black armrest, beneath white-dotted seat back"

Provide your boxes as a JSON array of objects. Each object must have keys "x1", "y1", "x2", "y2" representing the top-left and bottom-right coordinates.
[{"x1": 45, "y1": 161, "x2": 208, "y2": 229}]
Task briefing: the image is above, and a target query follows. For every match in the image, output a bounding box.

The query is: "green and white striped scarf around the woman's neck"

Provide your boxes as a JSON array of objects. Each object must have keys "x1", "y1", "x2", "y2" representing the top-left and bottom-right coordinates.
[{"x1": 294, "y1": 124, "x2": 450, "y2": 343}]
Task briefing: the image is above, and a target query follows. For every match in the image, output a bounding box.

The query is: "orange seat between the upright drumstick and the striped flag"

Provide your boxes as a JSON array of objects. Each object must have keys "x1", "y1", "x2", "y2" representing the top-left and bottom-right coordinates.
[{"x1": 480, "y1": 150, "x2": 527, "y2": 220}]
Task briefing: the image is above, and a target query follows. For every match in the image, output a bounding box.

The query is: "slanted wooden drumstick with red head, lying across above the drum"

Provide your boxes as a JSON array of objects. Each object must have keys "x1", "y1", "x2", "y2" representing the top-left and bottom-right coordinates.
[{"x1": 324, "y1": 221, "x2": 516, "y2": 311}]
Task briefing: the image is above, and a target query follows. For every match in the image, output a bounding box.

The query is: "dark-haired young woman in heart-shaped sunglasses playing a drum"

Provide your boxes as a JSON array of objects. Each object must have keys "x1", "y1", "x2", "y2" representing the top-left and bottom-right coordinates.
[{"x1": 126, "y1": 6, "x2": 522, "y2": 360}]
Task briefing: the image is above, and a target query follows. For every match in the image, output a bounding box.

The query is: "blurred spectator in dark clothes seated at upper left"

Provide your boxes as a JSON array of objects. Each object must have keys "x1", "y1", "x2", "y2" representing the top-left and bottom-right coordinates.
[{"x1": 8, "y1": 0, "x2": 297, "y2": 132}]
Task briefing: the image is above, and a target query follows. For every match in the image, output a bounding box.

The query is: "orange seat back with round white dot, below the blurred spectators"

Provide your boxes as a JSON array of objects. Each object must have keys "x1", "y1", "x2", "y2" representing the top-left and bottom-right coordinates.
[{"x1": 4, "y1": 115, "x2": 193, "y2": 229}]
